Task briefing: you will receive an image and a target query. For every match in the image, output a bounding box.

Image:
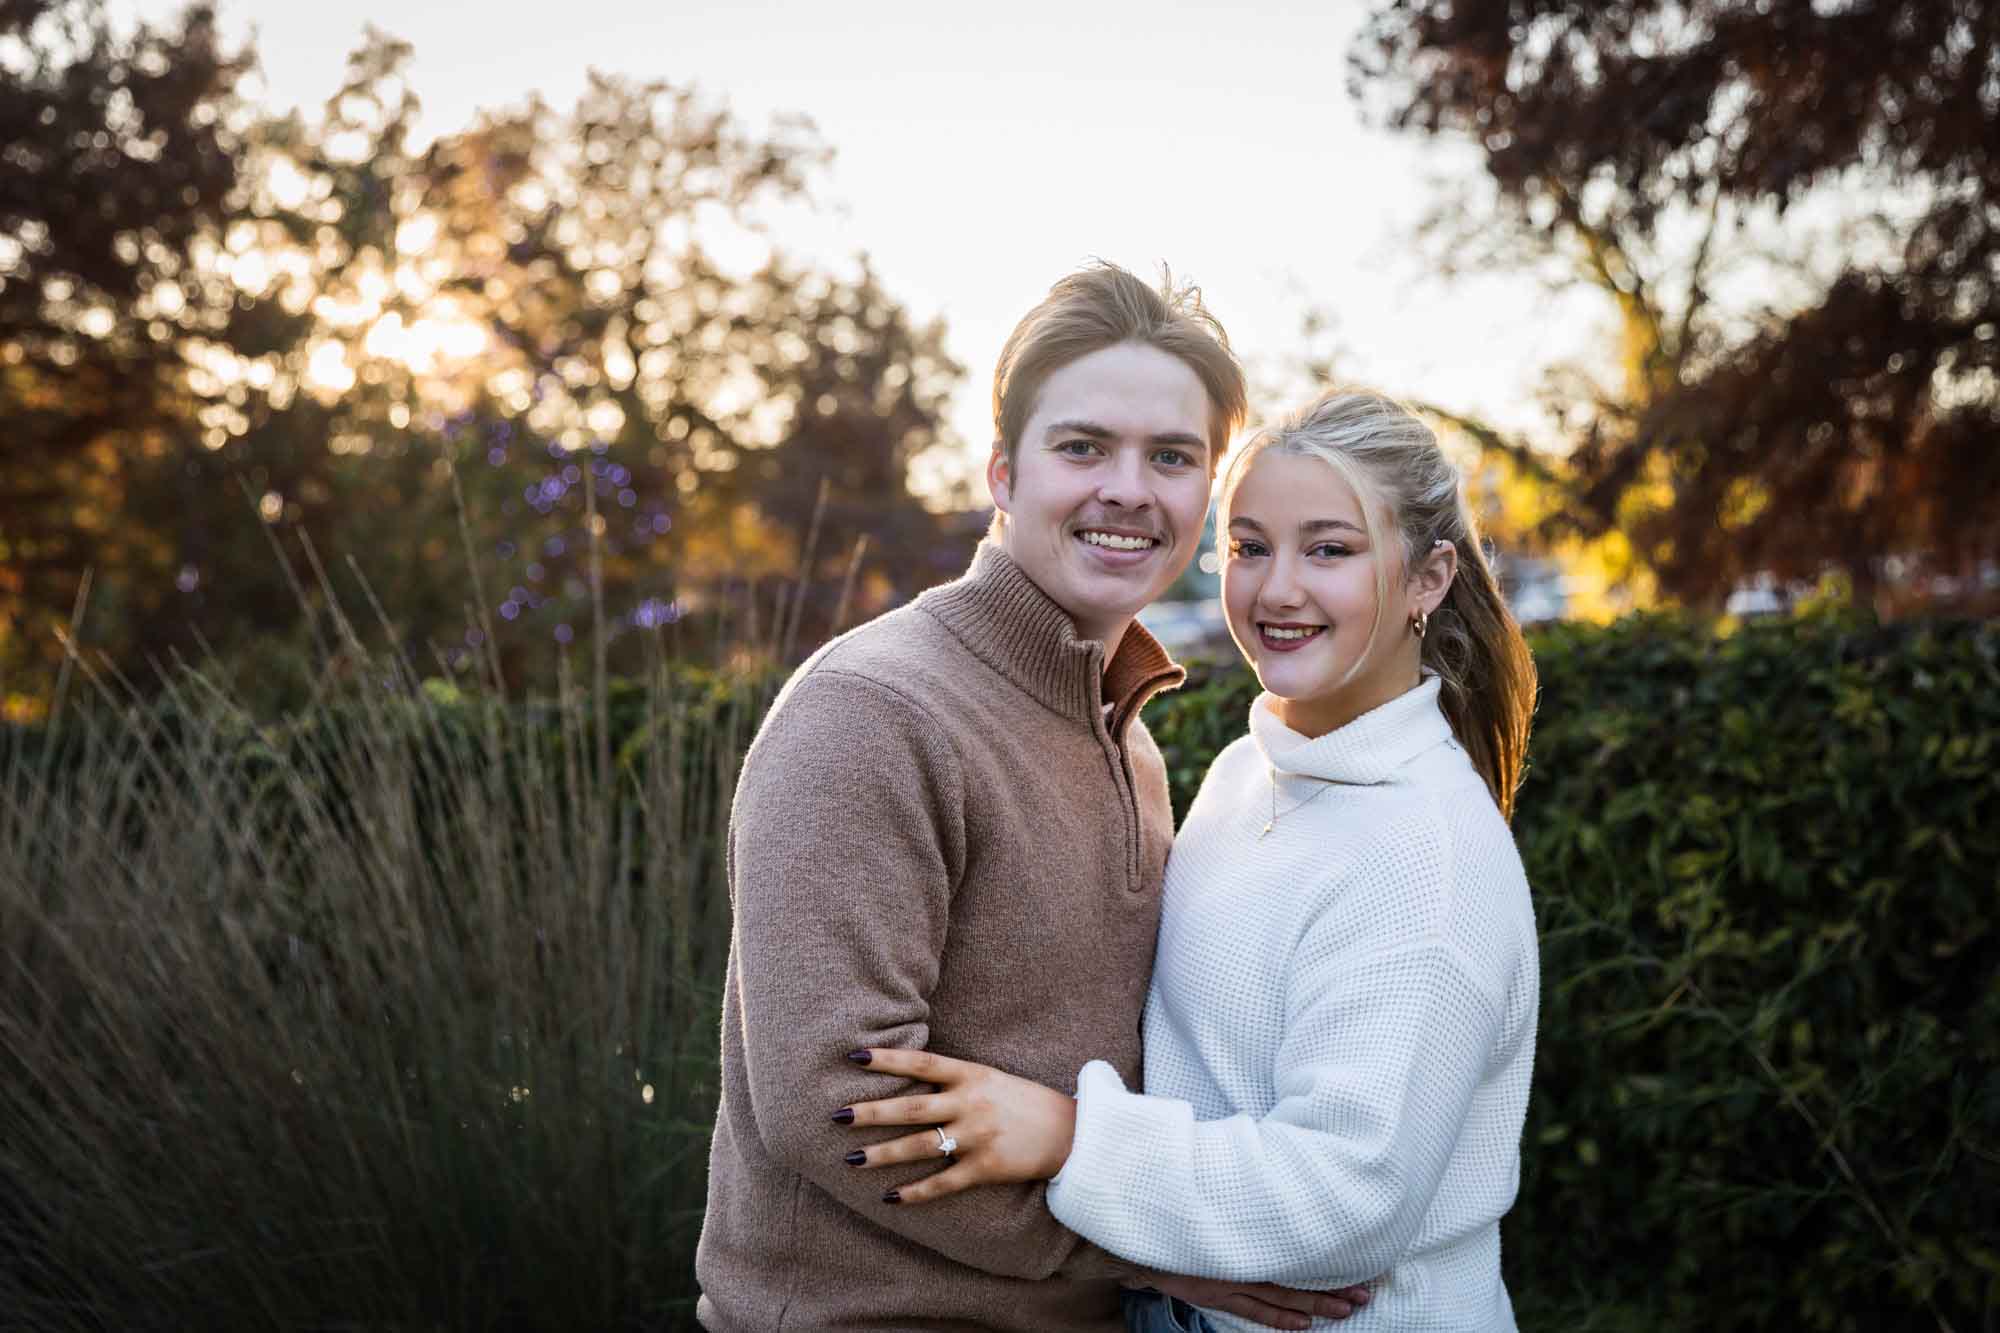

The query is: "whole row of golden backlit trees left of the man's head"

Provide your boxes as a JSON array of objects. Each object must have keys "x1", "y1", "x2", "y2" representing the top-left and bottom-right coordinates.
[{"x1": 0, "y1": 10, "x2": 964, "y2": 700}]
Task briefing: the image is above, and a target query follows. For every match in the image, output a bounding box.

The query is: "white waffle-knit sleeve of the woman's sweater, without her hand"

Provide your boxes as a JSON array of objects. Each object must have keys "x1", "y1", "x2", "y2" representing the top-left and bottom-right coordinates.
[{"x1": 1048, "y1": 836, "x2": 1500, "y2": 1289}]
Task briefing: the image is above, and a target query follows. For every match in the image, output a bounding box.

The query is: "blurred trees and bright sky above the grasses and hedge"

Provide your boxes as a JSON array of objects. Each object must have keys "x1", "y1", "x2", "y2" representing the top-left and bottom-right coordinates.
[{"x1": 0, "y1": 0, "x2": 2000, "y2": 704}]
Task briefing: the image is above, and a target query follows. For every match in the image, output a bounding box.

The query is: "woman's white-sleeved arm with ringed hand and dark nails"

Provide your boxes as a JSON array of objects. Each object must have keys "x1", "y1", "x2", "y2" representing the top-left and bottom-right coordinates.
[{"x1": 842, "y1": 933, "x2": 1500, "y2": 1283}]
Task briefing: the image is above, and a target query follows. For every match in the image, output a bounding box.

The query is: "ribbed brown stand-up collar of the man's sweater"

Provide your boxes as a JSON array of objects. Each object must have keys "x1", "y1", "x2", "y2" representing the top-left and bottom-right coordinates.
[{"x1": 916, "y1": 540, "x2": 1188, "y2": 737}]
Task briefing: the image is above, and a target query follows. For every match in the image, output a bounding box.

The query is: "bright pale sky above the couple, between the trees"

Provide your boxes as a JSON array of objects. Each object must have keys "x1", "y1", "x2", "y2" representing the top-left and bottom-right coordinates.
[{"x1": 116, "y1": 0, "x2": 1608, "y2": 492}]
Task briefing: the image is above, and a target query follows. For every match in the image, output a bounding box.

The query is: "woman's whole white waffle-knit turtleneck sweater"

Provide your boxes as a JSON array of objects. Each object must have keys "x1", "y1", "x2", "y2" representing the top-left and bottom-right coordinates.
[{"x1": 1048, "y1": 679, "x2": 1540, "y2": 1333}]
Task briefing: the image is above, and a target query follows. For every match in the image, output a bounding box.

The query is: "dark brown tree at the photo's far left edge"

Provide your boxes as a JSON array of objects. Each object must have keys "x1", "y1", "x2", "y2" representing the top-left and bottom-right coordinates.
[{"x1": 0, "y1": 0, "x2": 308, "y2": 684}]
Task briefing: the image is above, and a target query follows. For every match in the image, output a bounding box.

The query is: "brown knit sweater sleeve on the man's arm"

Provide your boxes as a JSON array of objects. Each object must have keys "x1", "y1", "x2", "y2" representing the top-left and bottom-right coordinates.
[{"x1": 728, "y1": 667, "x2": 1082, "y2": 1279}]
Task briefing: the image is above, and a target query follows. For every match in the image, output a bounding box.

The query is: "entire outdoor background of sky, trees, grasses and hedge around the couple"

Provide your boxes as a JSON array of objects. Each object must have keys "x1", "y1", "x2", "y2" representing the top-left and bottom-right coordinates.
[{"x1": 0, "y1": 0, "x2": 2000, "y2": 1333}]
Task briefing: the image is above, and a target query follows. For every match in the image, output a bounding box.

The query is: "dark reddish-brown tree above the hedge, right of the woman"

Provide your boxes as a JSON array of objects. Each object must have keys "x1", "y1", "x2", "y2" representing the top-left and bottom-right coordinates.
[{"x1": 1354, "y1": 0, "x2": 2000, "y2": 604}]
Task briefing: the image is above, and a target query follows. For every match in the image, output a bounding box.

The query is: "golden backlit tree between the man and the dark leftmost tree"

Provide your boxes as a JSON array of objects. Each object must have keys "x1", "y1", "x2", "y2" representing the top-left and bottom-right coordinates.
[{"x1": 386, "y1": 65, "x2": 966, "y2": 664}]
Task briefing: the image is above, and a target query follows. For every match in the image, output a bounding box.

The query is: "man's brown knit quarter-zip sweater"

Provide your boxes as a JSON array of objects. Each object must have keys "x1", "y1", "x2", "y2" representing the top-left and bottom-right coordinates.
[{"x1": 696, "y1": 544, "x2": 1182, "y2": 1333}]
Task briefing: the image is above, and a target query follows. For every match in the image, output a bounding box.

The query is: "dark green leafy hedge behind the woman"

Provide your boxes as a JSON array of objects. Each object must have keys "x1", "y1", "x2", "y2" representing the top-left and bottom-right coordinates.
[{"x1": 1150, "y1": 618, "x2": 2000, "y2": 1331}]
